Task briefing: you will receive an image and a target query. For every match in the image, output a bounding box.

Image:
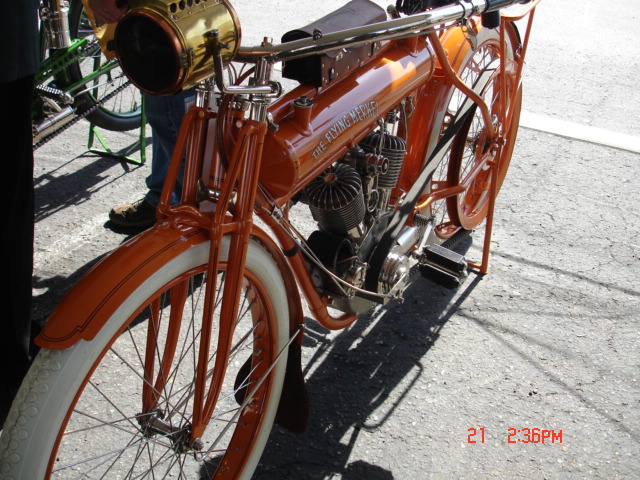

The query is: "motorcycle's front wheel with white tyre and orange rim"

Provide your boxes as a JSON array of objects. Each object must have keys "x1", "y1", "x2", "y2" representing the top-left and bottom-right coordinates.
[{"x1": 0, "y1": 238, "x2": 289, "y2": 479}]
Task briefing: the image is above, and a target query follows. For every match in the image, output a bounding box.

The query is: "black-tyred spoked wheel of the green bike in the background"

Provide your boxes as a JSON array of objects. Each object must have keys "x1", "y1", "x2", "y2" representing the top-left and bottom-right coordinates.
[{"x1": 63, "y1": 0, "x2": 142, "y2": 131}]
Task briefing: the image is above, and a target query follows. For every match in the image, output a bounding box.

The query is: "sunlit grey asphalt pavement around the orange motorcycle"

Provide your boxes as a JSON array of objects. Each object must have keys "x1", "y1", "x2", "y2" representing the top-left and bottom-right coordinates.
[{"x1": 27, "y1": 0, "x2": 640, "y2": 480}]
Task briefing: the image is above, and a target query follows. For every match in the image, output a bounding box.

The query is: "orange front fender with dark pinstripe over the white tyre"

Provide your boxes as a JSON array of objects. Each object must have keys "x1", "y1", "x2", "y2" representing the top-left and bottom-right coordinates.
[{"x1": 35, "y1": 221, "x2": 304, "y2": 349}]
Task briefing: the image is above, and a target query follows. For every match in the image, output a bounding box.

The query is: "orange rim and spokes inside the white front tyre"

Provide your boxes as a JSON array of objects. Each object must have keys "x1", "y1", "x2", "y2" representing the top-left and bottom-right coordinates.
[{"x1": 50, "y1": 266, "x2": 278, "y2": 479}]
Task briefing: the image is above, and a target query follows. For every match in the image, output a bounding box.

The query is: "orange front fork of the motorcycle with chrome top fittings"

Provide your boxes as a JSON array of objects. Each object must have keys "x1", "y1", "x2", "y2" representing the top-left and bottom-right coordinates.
[{"x1": 151, "y1": 48, "x2": 280, "y2": 444}]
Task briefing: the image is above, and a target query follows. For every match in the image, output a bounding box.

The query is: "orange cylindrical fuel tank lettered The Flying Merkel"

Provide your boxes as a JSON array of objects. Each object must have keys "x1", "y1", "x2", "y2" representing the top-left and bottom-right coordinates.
[{"x1": 260, "y1": 38, "x2": 435, "y2": 205}]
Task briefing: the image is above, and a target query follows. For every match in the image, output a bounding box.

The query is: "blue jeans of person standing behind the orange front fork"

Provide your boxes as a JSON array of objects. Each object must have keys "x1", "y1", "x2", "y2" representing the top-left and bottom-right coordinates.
[{"x1": 142, "y1": 89, "x2": 195, "y2": 207}]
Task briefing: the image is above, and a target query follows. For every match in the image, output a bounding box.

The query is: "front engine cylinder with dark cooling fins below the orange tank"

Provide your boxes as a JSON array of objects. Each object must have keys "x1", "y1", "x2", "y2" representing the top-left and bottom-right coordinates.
[{"x1": 305, "y1": 163, "x2": 365, "y2": 233}]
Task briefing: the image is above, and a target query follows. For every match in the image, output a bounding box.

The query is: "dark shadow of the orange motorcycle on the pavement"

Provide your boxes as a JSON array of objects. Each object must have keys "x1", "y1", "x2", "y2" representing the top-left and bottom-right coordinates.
[{"x1": 254, "y1": 251, "x2": 481, "y2": 480}]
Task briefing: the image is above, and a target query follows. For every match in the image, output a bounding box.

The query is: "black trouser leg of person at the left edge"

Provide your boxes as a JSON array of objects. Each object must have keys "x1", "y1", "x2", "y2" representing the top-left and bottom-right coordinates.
[{"x1": 0, "y1": 76, "x2": 34, "y2": 425}]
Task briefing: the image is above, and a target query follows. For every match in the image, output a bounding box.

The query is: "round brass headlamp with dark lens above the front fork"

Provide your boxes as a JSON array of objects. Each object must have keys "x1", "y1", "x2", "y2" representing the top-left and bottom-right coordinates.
[{"x1": 114, "y1": 0, "x2": 240, "y2": 95}]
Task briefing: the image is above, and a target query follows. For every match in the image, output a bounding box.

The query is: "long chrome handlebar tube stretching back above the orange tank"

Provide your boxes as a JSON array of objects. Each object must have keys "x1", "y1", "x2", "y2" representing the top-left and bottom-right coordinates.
[{"x1": 235, "y1": 0, "x2": 522, "y2": 62}]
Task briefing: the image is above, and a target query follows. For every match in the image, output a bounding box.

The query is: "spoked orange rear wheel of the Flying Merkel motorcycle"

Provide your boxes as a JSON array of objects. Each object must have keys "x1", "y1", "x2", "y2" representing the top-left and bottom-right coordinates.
[{"x1": 431, "y1": 23, "x2": 522, "y2": 239}]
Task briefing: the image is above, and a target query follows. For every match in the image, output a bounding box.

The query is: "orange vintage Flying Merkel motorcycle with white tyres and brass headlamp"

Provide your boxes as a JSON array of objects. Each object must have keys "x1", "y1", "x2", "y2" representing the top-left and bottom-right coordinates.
[{"x1": 0, "y1": 0, "x2": 539, "y2": 480}]
